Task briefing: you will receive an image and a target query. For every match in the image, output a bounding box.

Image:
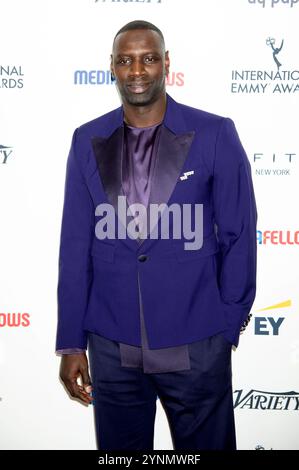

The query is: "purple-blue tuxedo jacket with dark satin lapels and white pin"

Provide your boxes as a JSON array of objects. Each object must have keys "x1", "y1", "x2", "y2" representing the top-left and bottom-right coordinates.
[{"x1": 56, "y1": 95, "x2": 257, "y2": 350}]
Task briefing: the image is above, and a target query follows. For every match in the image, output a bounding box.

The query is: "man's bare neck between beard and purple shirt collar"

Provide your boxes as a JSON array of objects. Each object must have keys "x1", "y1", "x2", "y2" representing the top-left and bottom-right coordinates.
[{"x1": 123, "y1": 94, "x2": 166, "y2": 127}]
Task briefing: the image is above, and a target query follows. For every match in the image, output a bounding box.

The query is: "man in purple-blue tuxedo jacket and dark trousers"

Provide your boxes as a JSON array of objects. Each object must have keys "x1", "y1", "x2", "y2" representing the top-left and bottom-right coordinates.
[{"x1": 56, "y1": 21, "x2": 257, "y2": 450}]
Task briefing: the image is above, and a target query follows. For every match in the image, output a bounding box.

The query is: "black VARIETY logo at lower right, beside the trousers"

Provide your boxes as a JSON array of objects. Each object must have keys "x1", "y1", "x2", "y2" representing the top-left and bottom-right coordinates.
[{"x1": 234, "y1": 390, "x2": 299, "y2": 411}]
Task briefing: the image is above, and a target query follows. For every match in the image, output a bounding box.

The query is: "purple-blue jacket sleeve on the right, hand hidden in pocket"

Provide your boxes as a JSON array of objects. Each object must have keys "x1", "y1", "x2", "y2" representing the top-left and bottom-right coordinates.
[{"x1": 213, "y1": 118, "x2": 257, "y2": 346}]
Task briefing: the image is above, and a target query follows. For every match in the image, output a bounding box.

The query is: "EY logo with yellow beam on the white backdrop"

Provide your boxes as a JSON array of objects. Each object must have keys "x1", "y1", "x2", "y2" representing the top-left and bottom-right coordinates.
[{"x1": 254, "y1": 300, "x2": 292, "y2": 336}]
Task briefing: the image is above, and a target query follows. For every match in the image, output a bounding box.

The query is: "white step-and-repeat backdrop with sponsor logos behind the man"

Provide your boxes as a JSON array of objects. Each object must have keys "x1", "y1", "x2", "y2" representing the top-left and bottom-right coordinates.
[{"x1": 0, "y1": 0, "x2": 299, "y2": 450}]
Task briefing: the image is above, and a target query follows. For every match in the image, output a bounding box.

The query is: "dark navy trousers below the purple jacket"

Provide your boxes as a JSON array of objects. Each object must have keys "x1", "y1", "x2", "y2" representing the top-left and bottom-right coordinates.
[{"x1": 88, "y1": 333, "x2": 236, "y2": 450}]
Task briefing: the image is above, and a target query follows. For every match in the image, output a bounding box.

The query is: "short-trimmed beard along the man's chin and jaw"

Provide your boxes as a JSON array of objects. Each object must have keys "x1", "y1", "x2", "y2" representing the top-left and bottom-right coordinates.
[{"x1": 116, "y1": 77, "x2": 165, "y2": 106}]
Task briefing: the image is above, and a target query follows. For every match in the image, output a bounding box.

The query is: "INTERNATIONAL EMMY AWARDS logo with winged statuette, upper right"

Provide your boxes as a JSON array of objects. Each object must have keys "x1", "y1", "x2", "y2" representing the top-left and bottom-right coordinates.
[{"x1": 231, "y1": 38, "x2": 299, "y2": 95}]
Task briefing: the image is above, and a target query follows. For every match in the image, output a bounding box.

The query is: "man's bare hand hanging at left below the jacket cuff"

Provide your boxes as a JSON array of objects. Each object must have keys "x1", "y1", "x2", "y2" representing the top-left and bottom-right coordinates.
[{"x1": 59, "y1": 353, "x2": 93, "y2": 405}]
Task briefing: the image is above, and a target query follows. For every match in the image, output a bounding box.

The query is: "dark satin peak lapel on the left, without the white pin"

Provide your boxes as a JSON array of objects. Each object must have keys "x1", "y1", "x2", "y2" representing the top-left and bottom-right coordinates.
[{"x1": 92, "y1": 126, "x2": 124, "y2": 213}]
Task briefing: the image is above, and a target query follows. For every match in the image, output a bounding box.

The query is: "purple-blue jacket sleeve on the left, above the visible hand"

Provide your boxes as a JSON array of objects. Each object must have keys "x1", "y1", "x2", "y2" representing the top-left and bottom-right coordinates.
[{"x1": 56, "y1": 129, "x2": 94, "y2": 351}]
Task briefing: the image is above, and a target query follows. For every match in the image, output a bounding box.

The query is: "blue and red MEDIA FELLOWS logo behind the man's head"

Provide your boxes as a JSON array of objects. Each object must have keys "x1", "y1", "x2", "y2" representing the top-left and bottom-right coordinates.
[{"x1": 74, "y1": 70, "x2": 185, "y2": 86}]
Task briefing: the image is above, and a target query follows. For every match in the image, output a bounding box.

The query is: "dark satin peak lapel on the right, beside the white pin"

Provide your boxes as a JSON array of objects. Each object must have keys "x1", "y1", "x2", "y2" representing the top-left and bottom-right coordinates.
[{"x1": 147, "y1": 127, "x2": 195, "y2": 239}]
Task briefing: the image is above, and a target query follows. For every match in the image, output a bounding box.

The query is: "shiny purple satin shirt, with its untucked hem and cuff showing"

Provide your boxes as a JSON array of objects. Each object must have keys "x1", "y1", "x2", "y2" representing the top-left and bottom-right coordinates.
[{"x1": 56, "y1": 123, "x2": 190, "y2": 373}]
